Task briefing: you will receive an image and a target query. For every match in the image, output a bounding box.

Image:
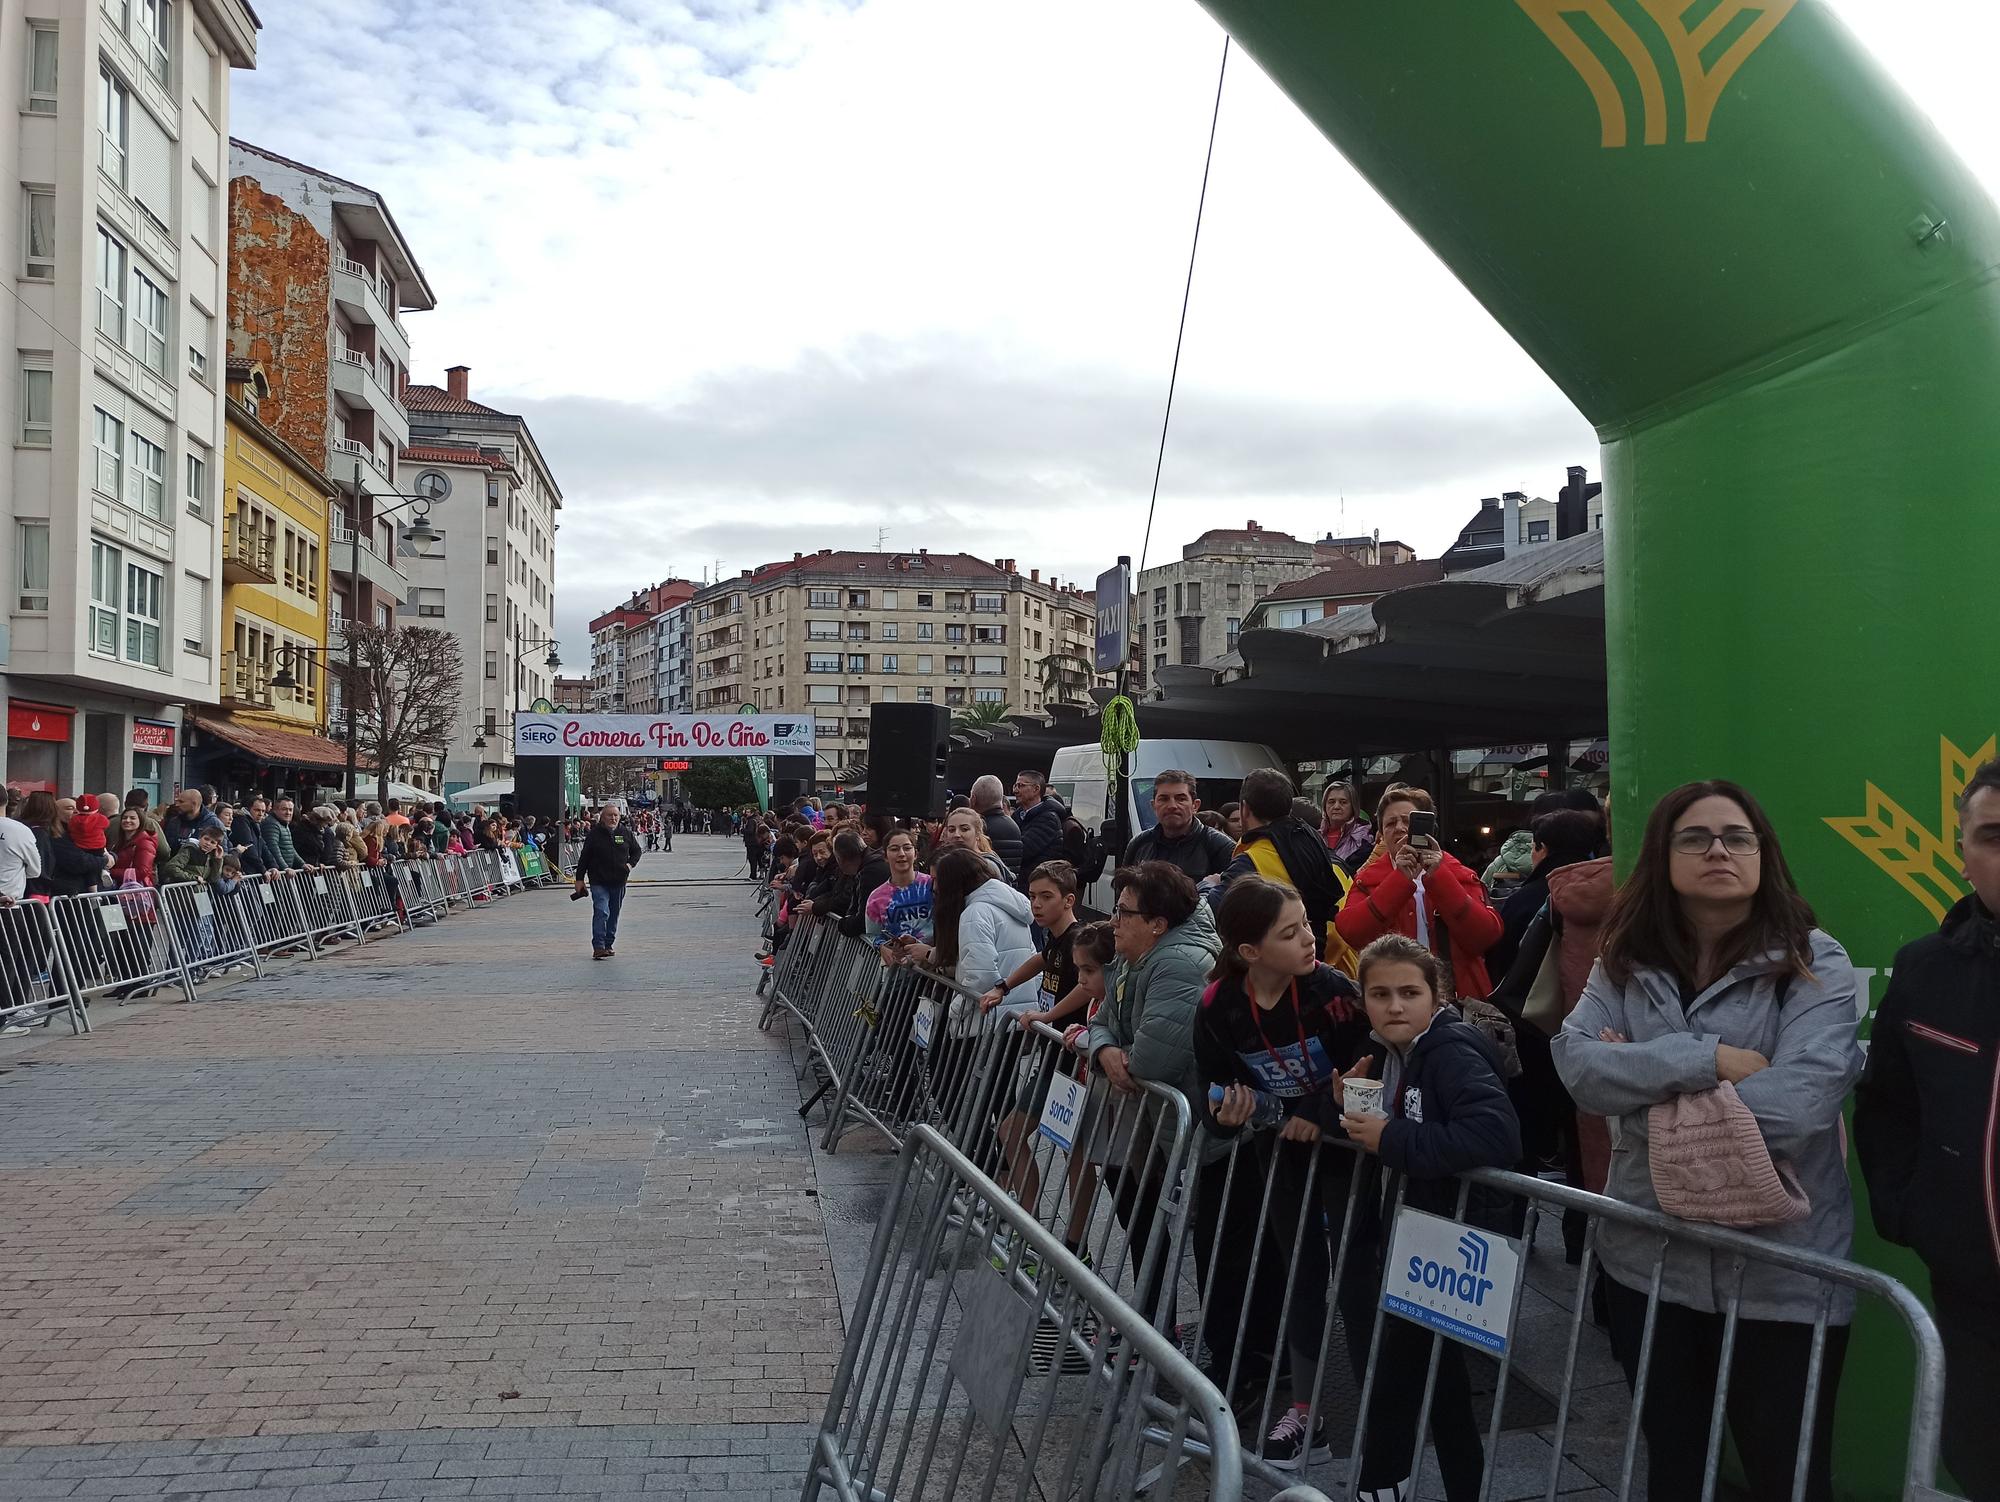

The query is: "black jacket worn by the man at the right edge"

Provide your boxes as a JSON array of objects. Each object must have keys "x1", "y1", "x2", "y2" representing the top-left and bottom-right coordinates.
[{"x1": 1854, "y1": 896, "x2": 2000, "y2": 1334}]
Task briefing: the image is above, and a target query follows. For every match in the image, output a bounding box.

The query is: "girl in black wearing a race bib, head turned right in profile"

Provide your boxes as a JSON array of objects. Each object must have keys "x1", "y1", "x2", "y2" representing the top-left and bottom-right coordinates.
[{"x1": 1194, "y1": 876, "x2": 1376, "y2": 1470}]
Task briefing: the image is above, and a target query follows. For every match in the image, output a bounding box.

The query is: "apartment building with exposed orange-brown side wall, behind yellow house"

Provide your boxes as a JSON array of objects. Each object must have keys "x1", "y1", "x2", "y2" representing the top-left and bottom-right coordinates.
[{"x1": 228, "y1": 140, "x2": 442, "y2": 648}]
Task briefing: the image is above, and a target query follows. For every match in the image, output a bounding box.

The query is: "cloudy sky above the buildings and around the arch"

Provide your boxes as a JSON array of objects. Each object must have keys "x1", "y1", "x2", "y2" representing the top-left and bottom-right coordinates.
[{"x1": 232, "y1": 0, "x2": 2000, "y2": 664}]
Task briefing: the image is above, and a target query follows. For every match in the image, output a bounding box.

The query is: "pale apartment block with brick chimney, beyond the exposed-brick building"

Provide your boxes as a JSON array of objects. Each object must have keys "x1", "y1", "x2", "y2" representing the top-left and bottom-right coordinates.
[{"x1": 398, "y1": 366, "x2": 562, "y2": 796}]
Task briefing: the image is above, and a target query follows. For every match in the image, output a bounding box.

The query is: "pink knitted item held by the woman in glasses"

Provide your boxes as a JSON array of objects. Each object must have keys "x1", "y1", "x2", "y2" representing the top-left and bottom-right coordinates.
[{"x1": 1646, "y1": 1080, "x2": 1812, "y2": 1226}]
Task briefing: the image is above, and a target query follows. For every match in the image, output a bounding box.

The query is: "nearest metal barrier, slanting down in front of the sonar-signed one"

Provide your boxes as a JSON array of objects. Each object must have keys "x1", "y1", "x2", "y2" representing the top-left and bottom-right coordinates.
[{"x1": 804, "y1": 1126, "x2": 1242, "y2": 1502}]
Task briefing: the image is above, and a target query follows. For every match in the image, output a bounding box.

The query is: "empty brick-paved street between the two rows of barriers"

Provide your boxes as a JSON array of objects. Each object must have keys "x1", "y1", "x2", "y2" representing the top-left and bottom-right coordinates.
[{"x1": 0, "y1": 836, "x2": 840, "y2": 1502}]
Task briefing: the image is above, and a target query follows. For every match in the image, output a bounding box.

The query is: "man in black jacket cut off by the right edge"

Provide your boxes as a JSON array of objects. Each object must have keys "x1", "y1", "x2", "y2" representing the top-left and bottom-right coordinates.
[{"x1": 1854, "y1": 762, "x2": 2000, "y2": 1502}]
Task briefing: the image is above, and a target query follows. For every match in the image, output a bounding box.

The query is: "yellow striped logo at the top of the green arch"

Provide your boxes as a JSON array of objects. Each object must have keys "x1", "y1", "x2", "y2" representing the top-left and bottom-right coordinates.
[{"x1": 1516, "y1": 0, "x2": 1798, "y2": 146}]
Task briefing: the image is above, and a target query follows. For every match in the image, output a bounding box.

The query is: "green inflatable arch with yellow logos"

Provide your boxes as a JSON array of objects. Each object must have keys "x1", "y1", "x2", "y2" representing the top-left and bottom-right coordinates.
[{"x1": 1202, "y1": 0, "x2": 2000, "y2": 1496}]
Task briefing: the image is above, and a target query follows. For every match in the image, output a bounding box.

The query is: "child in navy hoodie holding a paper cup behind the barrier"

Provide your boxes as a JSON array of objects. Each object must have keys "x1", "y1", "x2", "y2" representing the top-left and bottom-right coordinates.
[{"x1": 1340, "y1": 934, "x2": 1520, "y2": 1502}]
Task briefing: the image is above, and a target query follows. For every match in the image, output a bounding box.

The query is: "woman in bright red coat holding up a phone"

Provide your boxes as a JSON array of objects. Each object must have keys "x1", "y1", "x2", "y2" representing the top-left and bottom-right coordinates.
[{"x1": 1334, "y1": 788, "x2": 1502, "y2": 998}]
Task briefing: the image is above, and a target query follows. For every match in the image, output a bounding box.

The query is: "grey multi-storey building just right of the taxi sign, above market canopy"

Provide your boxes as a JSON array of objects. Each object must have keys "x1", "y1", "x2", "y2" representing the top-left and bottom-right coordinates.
[{"x1": 1132, "y1": 522, "x2": 1332, "y2": 684}]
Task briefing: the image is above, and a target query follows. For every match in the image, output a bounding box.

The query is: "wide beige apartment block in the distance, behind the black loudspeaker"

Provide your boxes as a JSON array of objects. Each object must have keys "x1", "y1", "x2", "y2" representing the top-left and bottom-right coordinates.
[{"x1": 690, "y1": 548, "x2": 1096, "y2": 784}]
